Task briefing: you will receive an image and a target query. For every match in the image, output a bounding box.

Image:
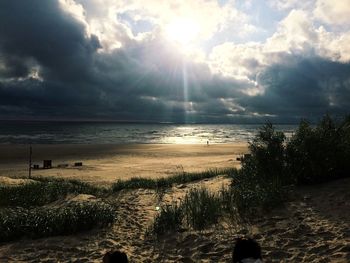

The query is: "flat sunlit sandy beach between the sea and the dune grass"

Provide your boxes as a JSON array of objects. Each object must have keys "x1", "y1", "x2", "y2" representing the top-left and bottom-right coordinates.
[{"x1": 0, "y1": 144, "x2": 248, "y2": 184}]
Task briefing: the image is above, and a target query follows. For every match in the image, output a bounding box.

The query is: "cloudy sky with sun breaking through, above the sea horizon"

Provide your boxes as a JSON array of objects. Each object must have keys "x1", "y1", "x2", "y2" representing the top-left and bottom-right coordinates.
[{"x1": 0, "y1": 0, "x2": 350, "y2": 122}]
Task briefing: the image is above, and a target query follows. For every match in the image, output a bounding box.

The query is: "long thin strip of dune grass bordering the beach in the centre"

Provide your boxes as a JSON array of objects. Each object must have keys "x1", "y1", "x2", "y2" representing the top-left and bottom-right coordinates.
[{"x1": 112, "y1": 168, "x2": 237, "y2": 192}]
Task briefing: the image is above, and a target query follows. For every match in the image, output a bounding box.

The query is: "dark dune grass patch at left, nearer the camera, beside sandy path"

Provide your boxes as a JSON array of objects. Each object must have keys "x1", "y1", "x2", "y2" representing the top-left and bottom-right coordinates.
[{"x1": 0, "y1": 202, "x2": 115, "y2": 242}]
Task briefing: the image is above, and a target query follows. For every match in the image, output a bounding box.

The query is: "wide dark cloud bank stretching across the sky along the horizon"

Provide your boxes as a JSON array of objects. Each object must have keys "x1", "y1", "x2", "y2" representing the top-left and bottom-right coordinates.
[{"x1": 0, "y1": 0, "x2": 350, "y2": 122}]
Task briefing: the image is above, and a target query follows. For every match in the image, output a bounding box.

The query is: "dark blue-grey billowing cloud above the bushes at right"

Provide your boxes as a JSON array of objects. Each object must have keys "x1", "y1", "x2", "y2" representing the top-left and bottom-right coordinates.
[{"x1": 239, "y1": 57, "x2": 350, "y2": 122}]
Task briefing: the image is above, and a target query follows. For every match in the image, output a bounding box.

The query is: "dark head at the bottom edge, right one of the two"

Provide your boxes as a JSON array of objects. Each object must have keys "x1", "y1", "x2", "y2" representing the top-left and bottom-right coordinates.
[{"x1": 232, "y1": 238, "x2": 262, "y2": 263}]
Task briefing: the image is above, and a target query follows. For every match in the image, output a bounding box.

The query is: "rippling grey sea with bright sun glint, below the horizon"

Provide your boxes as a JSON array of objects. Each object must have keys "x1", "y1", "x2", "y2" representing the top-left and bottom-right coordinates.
[{"x1": 0, "y1": 121, "x2": 297, "y2": 144}]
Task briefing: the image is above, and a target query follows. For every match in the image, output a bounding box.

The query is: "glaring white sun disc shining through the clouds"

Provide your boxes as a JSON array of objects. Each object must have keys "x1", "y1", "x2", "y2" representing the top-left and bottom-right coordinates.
[{"x1": 165, "y1": 18, "x2": 199, "y2": 46}]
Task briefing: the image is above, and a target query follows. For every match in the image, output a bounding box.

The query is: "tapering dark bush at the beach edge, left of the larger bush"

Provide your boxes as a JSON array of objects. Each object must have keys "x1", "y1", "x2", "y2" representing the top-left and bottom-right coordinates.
[{"x1": 223, "y1": 123, "x2": 291, "y2": 216}]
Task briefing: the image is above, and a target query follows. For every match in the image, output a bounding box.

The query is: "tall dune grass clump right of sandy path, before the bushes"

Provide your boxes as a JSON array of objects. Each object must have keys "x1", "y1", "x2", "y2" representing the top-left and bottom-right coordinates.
[{"x1": 150, "y1": 179, "x2": 286, "y2": 237}]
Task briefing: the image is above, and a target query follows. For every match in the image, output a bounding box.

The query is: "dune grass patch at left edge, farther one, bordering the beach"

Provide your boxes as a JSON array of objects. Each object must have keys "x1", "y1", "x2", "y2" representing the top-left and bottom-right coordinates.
[{"x1": 0, "y1": 177, "x2": 107, "y2": 207}]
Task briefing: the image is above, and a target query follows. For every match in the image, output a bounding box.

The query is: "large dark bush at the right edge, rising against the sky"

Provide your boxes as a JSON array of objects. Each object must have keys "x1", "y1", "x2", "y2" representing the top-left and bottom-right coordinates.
[{"x1": 286, "y1": 115, "x2": 350, "y2": 184}]
